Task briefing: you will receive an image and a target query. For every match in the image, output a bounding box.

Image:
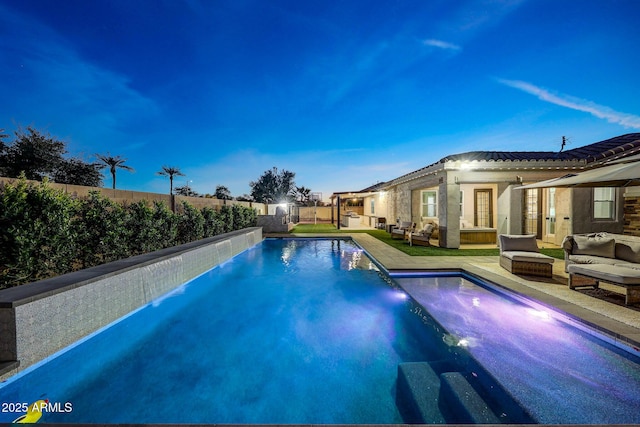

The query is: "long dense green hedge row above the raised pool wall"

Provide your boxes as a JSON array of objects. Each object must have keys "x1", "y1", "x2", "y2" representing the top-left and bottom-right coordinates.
[{"x1": 0, "y1": 179, "x2": 256, "y2": 289}]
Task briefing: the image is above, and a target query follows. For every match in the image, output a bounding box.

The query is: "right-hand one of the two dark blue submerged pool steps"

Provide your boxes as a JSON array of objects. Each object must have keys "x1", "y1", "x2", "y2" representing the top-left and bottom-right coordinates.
[{"x1": 439, "y1": 372, "x2": 501, "y2": 424}]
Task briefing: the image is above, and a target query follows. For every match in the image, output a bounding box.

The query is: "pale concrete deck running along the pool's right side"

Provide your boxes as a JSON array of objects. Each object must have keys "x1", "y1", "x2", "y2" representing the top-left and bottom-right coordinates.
[{"x1": 278, "y1": 233, "x2": 640, "y2": 347}]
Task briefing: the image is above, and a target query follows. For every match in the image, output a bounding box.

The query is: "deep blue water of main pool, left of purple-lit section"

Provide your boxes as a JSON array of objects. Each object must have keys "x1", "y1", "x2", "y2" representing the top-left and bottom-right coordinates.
[{"x1": 0, "y1": 240, "x2": 432, "y2": 423}]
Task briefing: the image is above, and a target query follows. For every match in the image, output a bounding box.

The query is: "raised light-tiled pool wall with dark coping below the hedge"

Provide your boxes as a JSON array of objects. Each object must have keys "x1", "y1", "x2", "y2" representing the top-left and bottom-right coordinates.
[{"x1": 0, "y1": 227, "x2": 262, "y2": 380}]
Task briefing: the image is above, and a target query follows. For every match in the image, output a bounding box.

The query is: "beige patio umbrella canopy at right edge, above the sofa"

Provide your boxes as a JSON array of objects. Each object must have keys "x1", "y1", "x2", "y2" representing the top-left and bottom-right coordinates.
[{"x1": 516, "y1": 161, "x2": 640, "y2": 190}]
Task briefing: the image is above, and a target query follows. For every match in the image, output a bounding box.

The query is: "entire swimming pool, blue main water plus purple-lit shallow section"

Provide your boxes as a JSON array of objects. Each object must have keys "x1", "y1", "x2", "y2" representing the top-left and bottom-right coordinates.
[{"x1": 0, "y1": 239, "x2": 640, "y2": 424}]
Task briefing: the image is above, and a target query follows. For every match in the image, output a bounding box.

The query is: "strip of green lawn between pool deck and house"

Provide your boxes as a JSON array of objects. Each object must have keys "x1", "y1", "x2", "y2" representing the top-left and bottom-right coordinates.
[{"x1": 291, "y1": 224, "x2": 564, "y2": 259}]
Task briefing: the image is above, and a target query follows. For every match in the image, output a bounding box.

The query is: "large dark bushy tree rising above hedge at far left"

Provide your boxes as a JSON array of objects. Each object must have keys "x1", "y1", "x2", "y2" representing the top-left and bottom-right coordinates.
[{"x1": 0, "y1": 126, "x2": 67, "y2": 181}]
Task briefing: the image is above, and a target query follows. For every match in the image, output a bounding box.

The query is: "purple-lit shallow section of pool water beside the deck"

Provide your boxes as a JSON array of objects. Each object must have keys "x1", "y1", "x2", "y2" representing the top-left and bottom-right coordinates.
[{"x1": 394, "y1": 276, "x2": 640, "y2": 424}]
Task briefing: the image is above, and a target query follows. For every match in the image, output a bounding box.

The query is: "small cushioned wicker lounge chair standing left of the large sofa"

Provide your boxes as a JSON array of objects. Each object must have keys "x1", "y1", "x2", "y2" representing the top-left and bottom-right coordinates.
[{"x1": 499, "y1": 234, "x2": 554, "y2": 277}]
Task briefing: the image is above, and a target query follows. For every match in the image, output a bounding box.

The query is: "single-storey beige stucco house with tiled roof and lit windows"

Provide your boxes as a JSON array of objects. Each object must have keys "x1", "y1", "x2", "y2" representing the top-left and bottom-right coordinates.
[{"x1": 361, "y1": 133, "x2": 640, "y2": 248}]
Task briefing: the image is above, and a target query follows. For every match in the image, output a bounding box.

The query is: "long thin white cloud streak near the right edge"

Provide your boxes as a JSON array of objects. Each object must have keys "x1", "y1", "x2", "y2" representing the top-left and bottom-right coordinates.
[{"x1": 497, "y1": 79, "x2": 640, "y2": 129}]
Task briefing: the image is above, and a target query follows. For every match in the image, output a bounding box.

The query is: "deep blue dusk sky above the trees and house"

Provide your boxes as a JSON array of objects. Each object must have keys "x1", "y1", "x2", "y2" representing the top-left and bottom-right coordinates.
[{"x1": 0, "y1": 0, "x2": 640, "y2": 199}]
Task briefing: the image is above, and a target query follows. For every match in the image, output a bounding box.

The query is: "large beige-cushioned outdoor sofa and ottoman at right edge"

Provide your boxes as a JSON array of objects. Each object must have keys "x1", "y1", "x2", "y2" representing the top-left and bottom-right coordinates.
[{"x1": 562, "y1": 232, "x2": 640, "y2": 305}]
